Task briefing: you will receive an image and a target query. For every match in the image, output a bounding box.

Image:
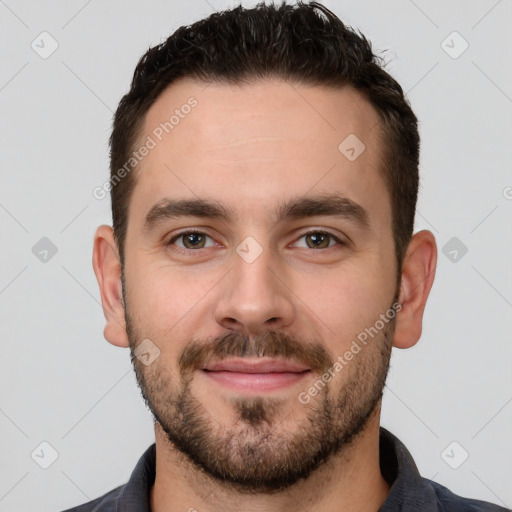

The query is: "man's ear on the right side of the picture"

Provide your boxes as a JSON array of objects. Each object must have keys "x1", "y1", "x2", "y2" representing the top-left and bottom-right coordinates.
[{"x1": 393, "y1": 230, "x2": 437, "y2": 348}]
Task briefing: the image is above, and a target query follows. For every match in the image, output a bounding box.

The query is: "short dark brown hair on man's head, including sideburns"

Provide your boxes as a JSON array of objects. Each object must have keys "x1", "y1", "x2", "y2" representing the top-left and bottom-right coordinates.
[{"x1": 110, "y1": 1, "x2": 420, "y2": 275}]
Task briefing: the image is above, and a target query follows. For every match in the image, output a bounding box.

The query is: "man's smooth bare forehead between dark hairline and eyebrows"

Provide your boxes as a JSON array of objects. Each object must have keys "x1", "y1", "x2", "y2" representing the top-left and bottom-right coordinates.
[{"x1": 130, "y1": 75, "x2": 390, "y2": 226}]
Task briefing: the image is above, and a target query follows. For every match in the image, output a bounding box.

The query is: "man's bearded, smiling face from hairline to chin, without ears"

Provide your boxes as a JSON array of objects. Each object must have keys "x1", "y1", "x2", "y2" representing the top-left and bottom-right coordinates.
[{"x1": 123, "y1": 80, "x2": 398, "y2": 492}]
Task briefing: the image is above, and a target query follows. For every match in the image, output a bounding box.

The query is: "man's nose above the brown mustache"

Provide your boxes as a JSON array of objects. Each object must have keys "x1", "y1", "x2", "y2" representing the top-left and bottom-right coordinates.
[{"x1": 215, "y1": 243, "x2": 295, "y2": 336}]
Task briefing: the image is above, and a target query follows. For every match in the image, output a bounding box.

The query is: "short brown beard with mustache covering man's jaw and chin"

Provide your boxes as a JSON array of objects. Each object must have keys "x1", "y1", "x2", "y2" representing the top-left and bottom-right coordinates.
[{"x1": 125, "y1": 301, "x2": 396, "y2": 494}]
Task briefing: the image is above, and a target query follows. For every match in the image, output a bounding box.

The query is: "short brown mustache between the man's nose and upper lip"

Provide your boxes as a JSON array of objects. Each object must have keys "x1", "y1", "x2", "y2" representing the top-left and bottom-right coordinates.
[{"x1": 179, "y1": 331, "x2": 334, "y2": 376}]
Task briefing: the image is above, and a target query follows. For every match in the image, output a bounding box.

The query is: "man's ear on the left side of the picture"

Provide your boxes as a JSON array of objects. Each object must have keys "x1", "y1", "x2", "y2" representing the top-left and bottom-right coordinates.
[{"x1": 92, "y1": 225, "x2": 130, "y2": 347}]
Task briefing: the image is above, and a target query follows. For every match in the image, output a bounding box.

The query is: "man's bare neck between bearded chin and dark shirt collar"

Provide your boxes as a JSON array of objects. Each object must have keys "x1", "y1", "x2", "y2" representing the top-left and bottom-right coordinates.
[{"x1": 150, "y1": 406, "x2": 389, "y2": 512}]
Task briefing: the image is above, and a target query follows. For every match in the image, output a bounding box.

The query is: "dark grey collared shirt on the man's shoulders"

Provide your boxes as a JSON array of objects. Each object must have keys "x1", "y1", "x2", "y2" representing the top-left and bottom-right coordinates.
[{"x1": 63, "y1": 427, "x2": 510, "y2": 512}]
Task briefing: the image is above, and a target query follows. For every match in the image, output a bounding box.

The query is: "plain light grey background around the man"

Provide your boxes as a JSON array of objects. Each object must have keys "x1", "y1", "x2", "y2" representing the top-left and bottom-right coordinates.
[{"x1": 0, "y1": 0, "x2": 512, "y2": 512}]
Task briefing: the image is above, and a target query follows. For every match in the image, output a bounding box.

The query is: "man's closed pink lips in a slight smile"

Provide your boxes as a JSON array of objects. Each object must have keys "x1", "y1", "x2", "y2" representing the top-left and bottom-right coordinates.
[{"x1": 201, "y1": 357, "x2": 311, "y2": 392}]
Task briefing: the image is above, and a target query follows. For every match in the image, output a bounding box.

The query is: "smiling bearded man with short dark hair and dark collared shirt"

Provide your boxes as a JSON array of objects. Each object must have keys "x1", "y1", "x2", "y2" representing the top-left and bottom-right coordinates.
[{"x1": 65, "y1": 2, "x2": 505, "y2": 512}]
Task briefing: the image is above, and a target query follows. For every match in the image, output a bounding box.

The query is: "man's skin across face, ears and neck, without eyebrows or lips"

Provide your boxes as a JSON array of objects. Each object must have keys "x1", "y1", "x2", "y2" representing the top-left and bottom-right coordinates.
[{"x1": 93, "y1": 79, "x2": 437, "y2": 512}]
